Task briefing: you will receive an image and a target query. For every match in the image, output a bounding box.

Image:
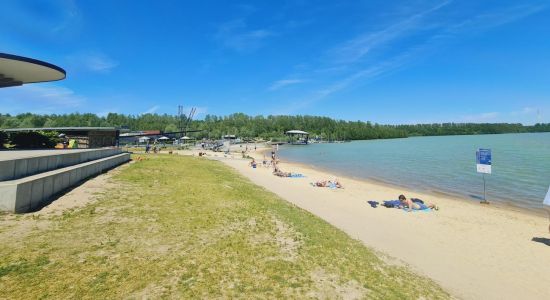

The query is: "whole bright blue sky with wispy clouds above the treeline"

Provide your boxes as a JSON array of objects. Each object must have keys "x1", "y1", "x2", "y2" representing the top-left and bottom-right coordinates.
[{"x1": 0, "y1": 0, "x2": 550, "y2": 124}]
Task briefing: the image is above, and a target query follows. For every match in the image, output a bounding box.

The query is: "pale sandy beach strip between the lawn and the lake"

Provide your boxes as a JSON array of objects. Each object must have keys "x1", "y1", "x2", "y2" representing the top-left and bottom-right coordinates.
[{"x1": 181, "y1": 148, "x2": 550, "y2": 299}]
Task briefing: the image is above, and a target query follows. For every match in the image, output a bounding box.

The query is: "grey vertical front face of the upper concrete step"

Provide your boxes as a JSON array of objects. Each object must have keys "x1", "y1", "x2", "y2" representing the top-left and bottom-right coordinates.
[{"x1": 0, "y1": 149, "x2": 121, "y2": 182}]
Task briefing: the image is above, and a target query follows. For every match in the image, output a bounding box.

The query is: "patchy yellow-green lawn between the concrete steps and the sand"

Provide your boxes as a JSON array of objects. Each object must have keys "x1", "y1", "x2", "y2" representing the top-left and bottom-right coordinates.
[{"x1": 0, "y1": 155, "x2": 449, "y2": 299}]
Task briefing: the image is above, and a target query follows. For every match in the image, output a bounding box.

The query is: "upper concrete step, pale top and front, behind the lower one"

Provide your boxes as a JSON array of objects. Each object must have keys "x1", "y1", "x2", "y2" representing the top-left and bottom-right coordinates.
[{"x1": 0, "y1": 148, "x2": 122, "y2": 182}]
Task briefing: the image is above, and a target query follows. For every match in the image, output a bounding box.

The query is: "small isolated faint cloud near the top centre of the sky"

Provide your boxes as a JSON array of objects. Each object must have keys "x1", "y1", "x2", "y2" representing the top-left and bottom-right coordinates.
[{"x1": 214, "y1": 19, "x2": 274, "y2": 53}]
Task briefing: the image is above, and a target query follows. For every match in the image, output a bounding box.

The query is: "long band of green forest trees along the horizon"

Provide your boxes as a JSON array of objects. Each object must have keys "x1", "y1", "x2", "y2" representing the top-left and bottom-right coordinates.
[{"x1": 0, "y1": 113, "x2": 550, "y2": 140}]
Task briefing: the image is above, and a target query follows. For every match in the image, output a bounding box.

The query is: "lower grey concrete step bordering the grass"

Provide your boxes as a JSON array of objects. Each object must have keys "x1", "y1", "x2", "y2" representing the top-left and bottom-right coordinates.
[{"x1": 0, "y1": 153, "x2": 130, "y2": 213}]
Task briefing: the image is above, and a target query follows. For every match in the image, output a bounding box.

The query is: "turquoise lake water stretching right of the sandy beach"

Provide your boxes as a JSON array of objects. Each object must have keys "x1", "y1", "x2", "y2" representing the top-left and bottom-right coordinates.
[{"x1": 279, "y1": 133, "x2": 550, "y2": 209}]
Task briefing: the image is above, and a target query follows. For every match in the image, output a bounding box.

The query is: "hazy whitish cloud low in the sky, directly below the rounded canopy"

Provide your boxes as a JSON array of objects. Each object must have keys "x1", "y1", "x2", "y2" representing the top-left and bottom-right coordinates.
[{"x1": 0, "y1": 84, "x2": 86, "y2": 114}]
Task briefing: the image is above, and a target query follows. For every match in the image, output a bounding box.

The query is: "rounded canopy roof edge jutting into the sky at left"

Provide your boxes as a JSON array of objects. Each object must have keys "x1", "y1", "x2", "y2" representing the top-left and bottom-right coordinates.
[{"x1": 0, "y1": 53, "x2": 66, "y2": 88}]
